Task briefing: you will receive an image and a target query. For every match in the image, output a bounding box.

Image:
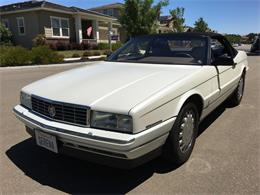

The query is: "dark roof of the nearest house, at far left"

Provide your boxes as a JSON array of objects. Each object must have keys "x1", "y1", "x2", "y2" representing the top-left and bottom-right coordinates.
[{"x1": 0, "y1": 0, "x2": 115, "y2": 19}]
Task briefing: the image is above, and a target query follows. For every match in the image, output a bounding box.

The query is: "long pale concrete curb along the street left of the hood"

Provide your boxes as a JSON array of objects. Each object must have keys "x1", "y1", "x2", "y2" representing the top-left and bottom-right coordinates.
[{"x1": 0, "y1": 61, "x2": 99, "y2": 71}]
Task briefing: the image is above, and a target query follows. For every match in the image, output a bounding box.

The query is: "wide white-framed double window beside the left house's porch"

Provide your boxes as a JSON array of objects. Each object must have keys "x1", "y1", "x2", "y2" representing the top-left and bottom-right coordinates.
[{"x1": 51, "y1": 16, "x2": 69, "y2": 37}]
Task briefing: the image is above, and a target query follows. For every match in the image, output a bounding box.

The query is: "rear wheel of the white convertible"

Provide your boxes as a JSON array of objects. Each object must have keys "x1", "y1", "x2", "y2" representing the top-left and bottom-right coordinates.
[{"x1": 228, "y1": 73, "x2": 245, "y2": 106}]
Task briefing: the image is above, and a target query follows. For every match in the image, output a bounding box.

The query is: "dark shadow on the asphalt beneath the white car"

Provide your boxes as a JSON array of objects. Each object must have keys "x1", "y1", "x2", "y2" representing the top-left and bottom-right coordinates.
[{"x1": 6, "y1": 105, "x2": 228, "y2": 194}]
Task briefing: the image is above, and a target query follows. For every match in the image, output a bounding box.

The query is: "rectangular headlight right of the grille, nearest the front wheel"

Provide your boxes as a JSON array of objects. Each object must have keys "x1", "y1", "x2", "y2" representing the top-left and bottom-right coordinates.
[{"x1": 91, "y1": 111, "x2": 133, "y2": 133}]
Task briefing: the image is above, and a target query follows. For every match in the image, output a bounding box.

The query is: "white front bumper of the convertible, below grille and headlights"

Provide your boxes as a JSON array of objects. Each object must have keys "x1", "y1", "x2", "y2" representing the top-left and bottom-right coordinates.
[{"x1": 13, "y1": 105, "x2": 175, "y2": 160}]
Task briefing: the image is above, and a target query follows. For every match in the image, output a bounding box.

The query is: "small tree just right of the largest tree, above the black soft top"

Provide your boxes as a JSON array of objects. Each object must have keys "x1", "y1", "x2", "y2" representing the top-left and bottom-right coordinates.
[{"x1": 170, "y1": 7, "x2": 185, "y2": 32}]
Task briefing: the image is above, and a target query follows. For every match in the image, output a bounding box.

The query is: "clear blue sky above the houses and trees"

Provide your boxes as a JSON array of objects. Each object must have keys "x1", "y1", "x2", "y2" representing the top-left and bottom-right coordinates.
[{"x1": 0, "y1": 0, "x2": 260, "y2": 35}]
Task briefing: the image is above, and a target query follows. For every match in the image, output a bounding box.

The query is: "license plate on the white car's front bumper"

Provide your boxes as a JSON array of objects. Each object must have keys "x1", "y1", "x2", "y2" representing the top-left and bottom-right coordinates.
[{"x1": 35, "y1": 130, "x2": 58, "y2": 153}]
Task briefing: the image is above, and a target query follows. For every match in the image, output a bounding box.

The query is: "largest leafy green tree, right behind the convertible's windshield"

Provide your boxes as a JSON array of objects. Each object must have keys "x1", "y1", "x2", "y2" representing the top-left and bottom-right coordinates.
[{"x1": 120, "y1": 0, "x2": 169, "y2": 37}]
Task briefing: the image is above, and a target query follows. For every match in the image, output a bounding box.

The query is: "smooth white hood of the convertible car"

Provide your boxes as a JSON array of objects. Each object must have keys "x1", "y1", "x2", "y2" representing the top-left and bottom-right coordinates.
[{"x1": 23, "y1": 62, "x2": 201, "y2": 114}]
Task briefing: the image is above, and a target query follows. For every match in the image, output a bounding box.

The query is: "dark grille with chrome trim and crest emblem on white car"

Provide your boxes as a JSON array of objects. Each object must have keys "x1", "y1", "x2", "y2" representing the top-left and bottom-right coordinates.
[{"x1": 31, "y1": 96, "x2": 88, "y2": 126}]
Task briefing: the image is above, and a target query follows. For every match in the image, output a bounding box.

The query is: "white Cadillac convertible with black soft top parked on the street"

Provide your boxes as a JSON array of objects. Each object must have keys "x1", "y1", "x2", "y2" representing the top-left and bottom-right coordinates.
[{"x1": 13, "y1": 33, "x2": 248, "y2": 168}]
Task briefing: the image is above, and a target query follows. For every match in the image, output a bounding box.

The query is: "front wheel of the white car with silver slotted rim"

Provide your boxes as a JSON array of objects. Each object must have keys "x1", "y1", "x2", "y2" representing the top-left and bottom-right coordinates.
[{"x1": 163, "y1": 102, "x2": 199, "y2": 165}]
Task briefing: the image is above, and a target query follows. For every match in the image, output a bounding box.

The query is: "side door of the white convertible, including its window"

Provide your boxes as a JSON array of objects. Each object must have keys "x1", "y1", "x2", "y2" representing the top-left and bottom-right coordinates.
[{"x1": 211, "y1": 37, "x2": 241, "y2": 97}]
